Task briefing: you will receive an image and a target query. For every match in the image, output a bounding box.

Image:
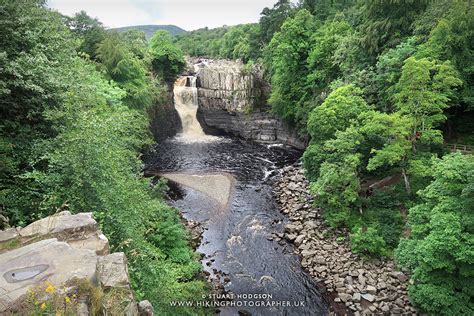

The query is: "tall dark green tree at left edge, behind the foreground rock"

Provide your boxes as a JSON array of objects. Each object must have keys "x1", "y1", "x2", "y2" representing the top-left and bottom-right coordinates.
[{"x1": 0, "y1": 0, "x2": 74, "y2": 224}]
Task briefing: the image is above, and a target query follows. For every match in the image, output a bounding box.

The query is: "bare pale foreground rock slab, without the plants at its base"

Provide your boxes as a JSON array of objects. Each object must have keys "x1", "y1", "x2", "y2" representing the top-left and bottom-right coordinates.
[{"x1": 0, "y1": 212, "x2": 144, "y2": 315}]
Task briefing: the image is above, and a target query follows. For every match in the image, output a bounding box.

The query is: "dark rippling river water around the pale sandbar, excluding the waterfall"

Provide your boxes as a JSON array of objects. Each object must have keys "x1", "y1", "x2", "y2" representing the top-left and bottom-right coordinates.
[{"x1": 146, "y1": 139, "x2": 327, "y2": 315}]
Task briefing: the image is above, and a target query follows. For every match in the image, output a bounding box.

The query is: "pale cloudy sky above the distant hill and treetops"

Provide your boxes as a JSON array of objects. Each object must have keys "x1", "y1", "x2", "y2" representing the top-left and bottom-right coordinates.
[{"x1": 48, "y1": 0, "x2": 277, "y2": 31}]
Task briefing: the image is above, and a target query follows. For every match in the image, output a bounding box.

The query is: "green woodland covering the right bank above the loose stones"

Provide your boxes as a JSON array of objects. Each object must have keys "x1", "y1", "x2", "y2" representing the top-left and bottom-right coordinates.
[{"x1": 176, "y1": 0, "x2": 474, "y2": 315}]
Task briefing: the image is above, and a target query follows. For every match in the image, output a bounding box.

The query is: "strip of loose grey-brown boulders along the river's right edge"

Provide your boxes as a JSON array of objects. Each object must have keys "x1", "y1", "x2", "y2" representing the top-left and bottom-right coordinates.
[{"x1": 274, "y1": 165, "x2": 416, "y2": 315}]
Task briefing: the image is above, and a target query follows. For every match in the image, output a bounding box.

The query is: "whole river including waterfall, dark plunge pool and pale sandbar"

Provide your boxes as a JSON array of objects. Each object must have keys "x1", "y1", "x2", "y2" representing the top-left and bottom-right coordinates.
[{"x1": 145, "y1": 77, "x2": 328, "y2": 315}]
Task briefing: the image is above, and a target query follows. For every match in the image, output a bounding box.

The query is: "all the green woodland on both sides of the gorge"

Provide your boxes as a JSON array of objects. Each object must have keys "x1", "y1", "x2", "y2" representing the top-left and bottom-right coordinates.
[{"x1": 0, "y1": 0, "x2": 474, "y2": 315}]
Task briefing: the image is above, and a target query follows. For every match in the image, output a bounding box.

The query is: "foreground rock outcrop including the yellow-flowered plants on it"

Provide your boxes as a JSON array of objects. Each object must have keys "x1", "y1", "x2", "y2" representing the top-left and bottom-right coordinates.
[{"x1": 0, "y1": 211, "x2": 152, "y2": 316}]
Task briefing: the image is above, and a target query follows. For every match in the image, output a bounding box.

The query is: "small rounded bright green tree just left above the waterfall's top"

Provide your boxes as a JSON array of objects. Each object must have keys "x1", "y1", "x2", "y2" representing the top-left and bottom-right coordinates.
[{"x1": 149, "y1": 31, "x2": 185, "y2": 83}]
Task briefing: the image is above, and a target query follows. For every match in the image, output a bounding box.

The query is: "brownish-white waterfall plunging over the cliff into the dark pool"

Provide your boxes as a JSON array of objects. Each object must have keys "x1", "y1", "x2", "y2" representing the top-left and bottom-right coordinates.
[{"x1": 173, "y1": 76, "x2": 219, "y2": 142}]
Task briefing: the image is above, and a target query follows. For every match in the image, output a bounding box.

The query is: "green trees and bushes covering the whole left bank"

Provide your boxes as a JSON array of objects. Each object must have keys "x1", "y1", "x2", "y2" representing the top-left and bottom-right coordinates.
[{"x1": 0, "y1": 0, "x2": 206, "y2": 315}]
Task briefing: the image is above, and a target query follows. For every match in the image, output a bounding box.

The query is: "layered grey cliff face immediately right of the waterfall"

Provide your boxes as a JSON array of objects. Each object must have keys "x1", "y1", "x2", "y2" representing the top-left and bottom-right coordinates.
[{"x1": 193, "y1": 60, "x2": 306, "y2": 149}]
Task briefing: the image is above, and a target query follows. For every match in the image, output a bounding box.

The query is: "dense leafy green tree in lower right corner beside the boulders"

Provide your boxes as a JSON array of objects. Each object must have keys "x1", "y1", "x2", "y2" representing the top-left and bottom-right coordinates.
[{"x1": 396, "y1": 154, "x2": 474, "y2": 315}]
